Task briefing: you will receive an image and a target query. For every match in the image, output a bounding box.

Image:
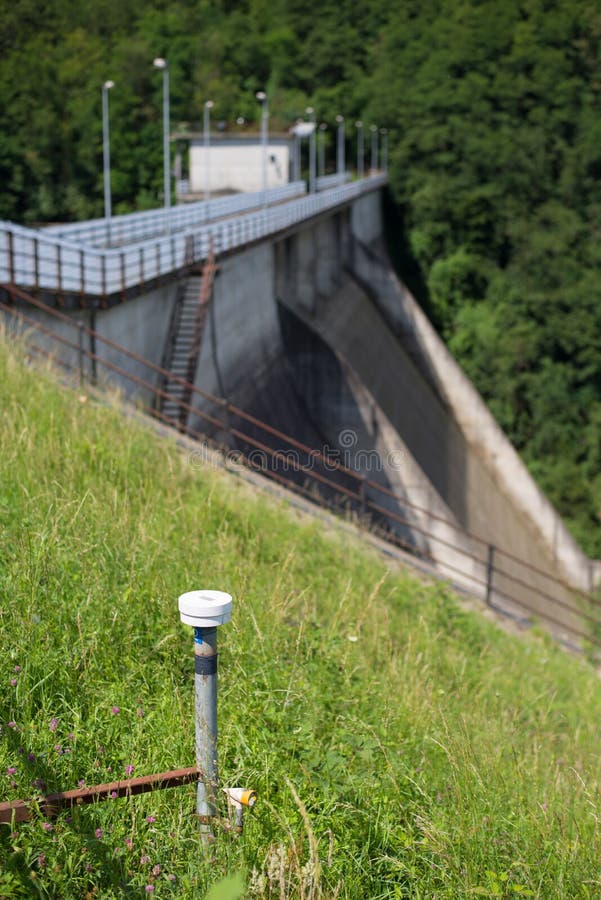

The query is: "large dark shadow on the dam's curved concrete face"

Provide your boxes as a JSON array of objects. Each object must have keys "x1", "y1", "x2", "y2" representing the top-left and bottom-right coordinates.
[{"x1": 188, "y1": 292, "x2": 429, "y2": 556}]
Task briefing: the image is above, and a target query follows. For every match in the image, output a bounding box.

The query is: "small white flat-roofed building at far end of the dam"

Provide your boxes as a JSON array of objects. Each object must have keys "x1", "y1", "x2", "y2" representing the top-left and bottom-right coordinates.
[{"x1": 188, "y1": 133, "x2": 293, "y2": 194}]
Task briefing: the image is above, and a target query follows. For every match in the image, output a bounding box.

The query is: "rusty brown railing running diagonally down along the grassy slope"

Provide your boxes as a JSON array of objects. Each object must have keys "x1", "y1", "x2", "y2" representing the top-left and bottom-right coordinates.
[{"x1": 0, "y1": 286, "x2": 601, "y2": 649}]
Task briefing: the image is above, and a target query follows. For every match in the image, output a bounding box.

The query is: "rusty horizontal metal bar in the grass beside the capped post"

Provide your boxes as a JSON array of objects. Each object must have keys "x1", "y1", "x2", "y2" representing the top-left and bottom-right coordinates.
[{"x1": 0, "y1": 766, "x2": 199, "y2": 824}]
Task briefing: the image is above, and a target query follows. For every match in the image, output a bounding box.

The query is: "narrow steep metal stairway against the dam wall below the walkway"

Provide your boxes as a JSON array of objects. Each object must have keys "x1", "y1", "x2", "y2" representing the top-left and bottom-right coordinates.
[{"x1": 159, "y1": 244, "x2": 219, "y2": 431}]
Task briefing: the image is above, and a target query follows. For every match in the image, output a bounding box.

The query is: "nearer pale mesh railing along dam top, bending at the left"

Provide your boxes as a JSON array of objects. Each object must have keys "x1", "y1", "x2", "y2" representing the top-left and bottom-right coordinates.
[{"x1": 0, "y1": 175, "x2": 387, "y2": 305}]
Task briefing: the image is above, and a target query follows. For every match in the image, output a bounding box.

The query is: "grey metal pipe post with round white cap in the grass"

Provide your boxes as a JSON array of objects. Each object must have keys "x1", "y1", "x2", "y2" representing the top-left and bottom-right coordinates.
[{"x1": 178, "y1": 591, "x2": 232, "y2": 848}]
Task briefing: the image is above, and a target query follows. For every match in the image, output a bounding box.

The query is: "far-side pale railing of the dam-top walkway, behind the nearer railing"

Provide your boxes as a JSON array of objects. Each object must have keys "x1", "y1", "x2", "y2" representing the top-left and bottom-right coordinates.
[{"x1": 42, "y1": 181, "x2": 307, "y2": 247}]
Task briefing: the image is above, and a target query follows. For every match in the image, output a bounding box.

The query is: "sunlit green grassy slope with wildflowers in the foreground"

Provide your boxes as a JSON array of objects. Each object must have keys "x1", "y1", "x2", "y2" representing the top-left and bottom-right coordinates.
[{"x1": 0, "y1": 346, "x2": 601, "y2": 900}]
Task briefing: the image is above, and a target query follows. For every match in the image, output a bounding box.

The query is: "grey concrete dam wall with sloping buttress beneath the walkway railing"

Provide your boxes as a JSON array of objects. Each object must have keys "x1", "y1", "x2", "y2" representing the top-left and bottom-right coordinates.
[{"x1": 2, "y1": 185, "x2": 600, "y2": 645}]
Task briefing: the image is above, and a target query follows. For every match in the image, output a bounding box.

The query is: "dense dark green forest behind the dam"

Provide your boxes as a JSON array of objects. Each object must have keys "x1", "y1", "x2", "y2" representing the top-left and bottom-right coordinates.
[{"x1": 0, "y1": 0, "x2": 601, "y2": 557}]
